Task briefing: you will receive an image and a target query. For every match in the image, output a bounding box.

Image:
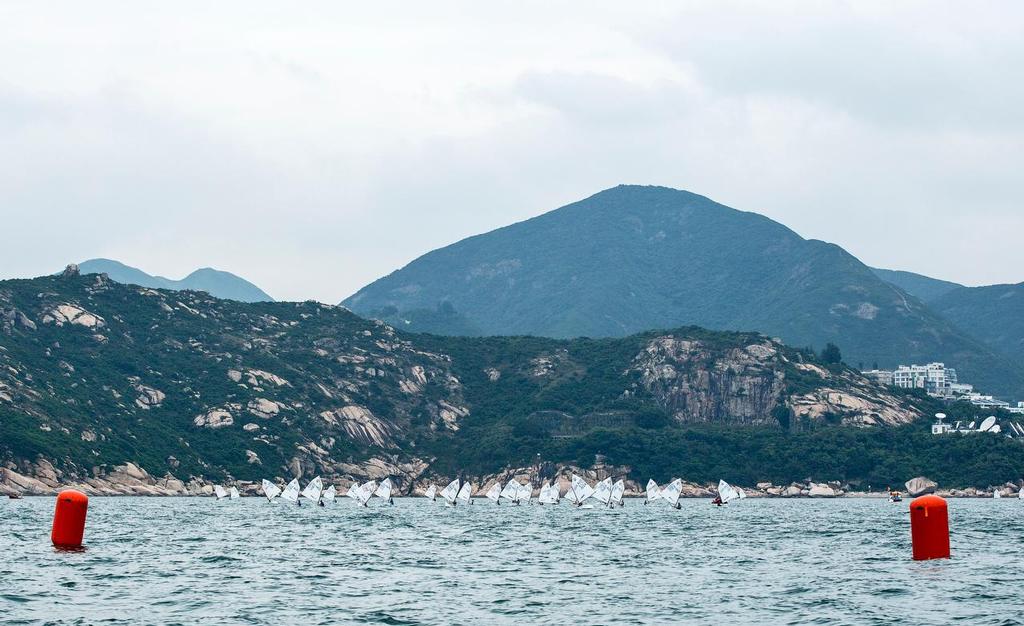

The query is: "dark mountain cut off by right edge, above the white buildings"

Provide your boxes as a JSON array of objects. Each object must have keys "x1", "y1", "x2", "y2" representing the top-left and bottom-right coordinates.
[{"x1": 929, "y1": 283, "x2": 1024, "y2": 361}]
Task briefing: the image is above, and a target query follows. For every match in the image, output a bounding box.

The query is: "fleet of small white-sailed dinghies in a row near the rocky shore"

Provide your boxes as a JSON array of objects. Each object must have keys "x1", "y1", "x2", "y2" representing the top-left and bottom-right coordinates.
[{"x1": 213, "y1": 474, "x2": 761, "y2": 509}]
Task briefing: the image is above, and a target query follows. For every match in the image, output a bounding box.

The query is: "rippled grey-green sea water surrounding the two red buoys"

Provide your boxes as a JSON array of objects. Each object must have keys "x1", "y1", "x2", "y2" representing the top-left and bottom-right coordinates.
[{"x1": 0, "y1": 498, "x2": 1024, "y2": 625}]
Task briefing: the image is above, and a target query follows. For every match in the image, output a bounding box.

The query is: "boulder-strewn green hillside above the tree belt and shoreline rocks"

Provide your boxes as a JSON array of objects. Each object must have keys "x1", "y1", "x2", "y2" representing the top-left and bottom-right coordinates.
[{"x1": 0, "y1": 274, "x2": 920, "y2": 489}]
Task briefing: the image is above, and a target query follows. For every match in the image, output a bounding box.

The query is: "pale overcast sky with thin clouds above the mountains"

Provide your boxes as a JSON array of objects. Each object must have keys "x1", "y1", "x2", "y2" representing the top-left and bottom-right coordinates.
[{"x1": 0, "y1": 0, "x2": 1024, "y2": 303}]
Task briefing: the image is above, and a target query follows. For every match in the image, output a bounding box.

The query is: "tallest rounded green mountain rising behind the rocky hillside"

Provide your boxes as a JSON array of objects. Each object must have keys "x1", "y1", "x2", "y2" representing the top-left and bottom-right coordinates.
[{"x1": 343, "y1": 185, "x2": 1024, "y2": 395}]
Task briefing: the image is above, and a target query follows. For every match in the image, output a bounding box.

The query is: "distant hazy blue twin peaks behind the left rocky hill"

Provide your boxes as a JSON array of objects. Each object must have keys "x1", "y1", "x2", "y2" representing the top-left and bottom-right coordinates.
[{"x1": 79, "y1": 258, "x2": 273, "y2": 302}]
